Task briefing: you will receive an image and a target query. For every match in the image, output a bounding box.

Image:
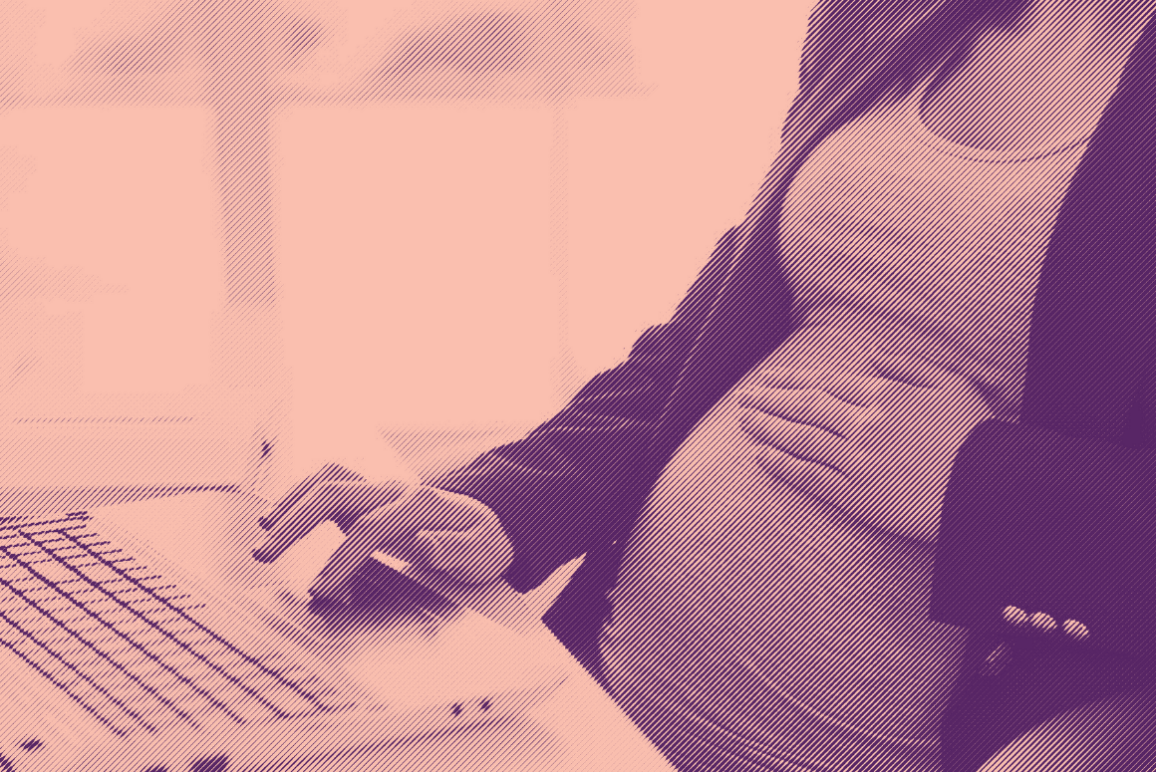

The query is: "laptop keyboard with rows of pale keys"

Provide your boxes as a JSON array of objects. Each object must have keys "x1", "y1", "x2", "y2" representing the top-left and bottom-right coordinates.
[{"x1": 0, "y1": 515, "x2": 347, "y2": 735}]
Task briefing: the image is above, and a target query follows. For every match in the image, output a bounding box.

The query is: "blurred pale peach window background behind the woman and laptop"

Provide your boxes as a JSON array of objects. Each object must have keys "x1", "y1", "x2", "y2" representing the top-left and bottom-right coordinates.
[{"x1": 0, "y1": 0, "x2": 810, "y2": 487}]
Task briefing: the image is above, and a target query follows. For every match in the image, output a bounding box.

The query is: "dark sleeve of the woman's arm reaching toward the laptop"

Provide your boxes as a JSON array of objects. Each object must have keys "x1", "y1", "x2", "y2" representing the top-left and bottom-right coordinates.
[{"x1": 428, "y1": 229, "x2": 736, "y2": 591}]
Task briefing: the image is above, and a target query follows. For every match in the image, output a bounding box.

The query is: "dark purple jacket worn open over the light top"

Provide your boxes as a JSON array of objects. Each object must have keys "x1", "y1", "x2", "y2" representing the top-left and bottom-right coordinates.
[{"x1": 430, "y1": 0, "x2": 1156, "y2": 772}]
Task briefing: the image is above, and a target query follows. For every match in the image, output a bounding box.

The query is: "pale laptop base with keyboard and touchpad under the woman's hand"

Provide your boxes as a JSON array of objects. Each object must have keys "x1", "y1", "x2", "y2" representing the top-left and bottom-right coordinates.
[{"x1": 0, "y1": 491, "x2": 564, "y2": 772}]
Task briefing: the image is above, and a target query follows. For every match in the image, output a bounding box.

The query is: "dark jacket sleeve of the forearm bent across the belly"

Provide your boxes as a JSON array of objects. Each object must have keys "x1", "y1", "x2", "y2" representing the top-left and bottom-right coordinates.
[{"x1": 932, "y1": 421, "x2": 1156, "y2": 656}]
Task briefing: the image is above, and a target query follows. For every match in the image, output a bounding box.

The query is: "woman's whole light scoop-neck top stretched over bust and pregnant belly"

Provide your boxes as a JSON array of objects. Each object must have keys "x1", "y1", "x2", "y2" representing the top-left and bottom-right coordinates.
[{"x1": 600, "y1": 73, "x2": 1087, "y2": 771}]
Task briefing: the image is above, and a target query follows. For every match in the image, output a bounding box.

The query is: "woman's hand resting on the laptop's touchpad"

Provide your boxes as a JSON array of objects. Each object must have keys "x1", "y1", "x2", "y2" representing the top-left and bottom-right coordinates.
[{"x1": 253, "y1": 465, "x2": 513, "y2": 601}]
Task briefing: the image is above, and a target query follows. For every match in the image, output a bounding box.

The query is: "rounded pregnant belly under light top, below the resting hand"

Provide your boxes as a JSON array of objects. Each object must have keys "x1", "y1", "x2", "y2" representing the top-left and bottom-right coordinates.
[{"x1": 602, "y1": 331, "x2": 964, "y2": 747}]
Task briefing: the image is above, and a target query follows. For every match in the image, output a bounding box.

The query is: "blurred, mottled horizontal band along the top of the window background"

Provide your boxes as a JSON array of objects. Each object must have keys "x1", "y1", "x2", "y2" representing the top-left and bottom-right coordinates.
[{"x1": 0, "y1": 0, "x2": 635, "y2": 110}]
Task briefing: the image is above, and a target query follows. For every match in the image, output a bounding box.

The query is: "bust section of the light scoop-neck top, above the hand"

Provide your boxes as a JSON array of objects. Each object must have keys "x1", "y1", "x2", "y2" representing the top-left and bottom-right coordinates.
[{"x1": 780, "y1": 75, "x2": 1090, "y2": 421}]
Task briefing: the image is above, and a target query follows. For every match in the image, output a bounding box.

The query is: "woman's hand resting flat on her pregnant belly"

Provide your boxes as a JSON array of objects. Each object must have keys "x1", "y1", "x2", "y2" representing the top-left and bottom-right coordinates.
[{"x1": 741, "y1": 355, "x2": 991, "y2": 542}]
